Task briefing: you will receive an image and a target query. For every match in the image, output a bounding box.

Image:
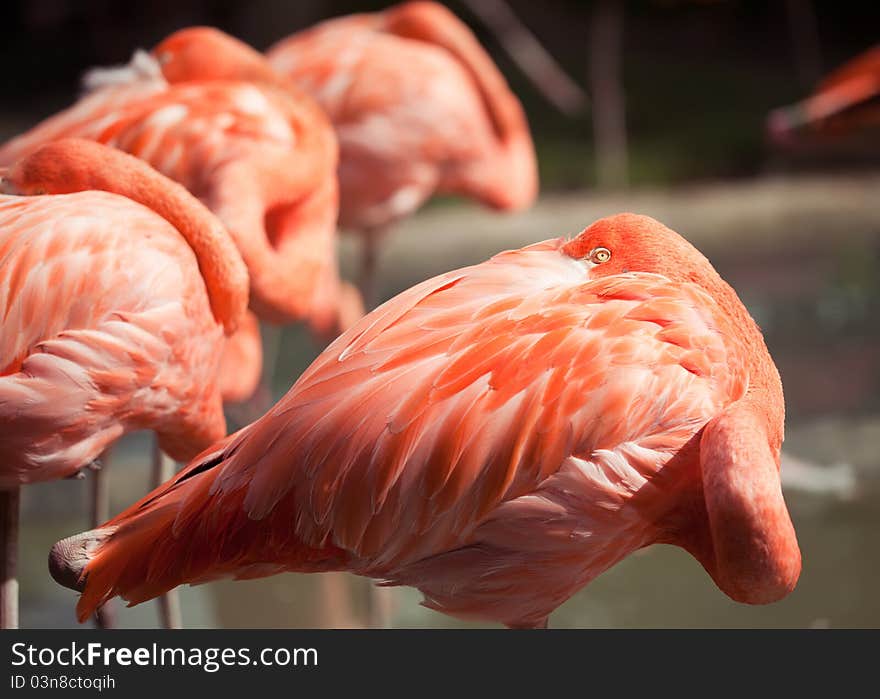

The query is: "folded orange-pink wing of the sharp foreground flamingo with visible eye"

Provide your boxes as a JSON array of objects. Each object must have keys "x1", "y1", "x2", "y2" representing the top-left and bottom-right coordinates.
[{"x1": 191, "y1": 240, "x2": 747, "y2": 569}]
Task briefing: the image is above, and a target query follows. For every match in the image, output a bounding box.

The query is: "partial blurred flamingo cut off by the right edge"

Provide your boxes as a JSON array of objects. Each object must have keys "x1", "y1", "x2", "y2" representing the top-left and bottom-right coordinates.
[{"x1": 767, "y1": 45, "x2": 880, "y2": 144}]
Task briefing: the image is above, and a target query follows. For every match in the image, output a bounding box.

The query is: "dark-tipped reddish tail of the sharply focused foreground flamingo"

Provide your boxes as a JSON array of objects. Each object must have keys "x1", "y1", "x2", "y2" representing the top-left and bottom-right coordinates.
[{"x1": 49, "y1": 428, "x2": 339, "y2": 622}]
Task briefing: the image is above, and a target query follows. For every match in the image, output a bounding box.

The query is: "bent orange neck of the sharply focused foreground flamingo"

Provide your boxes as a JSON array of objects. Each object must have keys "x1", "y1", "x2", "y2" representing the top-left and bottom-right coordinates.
[{"x1": 690, "y1": 270, "x2": 801, "y2": 604}]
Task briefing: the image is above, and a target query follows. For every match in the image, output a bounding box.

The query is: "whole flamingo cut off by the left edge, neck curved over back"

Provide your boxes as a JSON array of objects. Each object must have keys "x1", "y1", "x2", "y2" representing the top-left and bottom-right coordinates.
[{"x1": 0, "y1": 140, "x2": 248, "y2": 628}]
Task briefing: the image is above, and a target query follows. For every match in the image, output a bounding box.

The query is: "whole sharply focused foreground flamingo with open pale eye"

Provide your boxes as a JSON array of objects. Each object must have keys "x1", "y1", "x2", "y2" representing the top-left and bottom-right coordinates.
[{"x1": 49, "y1": 214, "x2": 800, "y2": 628}]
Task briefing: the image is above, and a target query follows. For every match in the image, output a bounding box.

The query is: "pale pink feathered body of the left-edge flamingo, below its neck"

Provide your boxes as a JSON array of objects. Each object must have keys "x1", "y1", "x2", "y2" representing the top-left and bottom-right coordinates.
[{"x1": 0, "y1": 192, "x2": 225, "y2": 482}]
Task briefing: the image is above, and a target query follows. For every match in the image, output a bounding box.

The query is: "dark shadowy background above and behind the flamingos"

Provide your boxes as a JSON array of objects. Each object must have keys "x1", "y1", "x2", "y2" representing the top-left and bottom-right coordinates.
[{"x1": 0, "y1": 0, "x2": 880, "y2": 188}]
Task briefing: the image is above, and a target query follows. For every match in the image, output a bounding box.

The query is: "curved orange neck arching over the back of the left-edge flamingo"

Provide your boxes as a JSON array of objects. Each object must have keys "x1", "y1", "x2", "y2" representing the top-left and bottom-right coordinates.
[{"x1": 6, "y1": 139, "x2": 248, "y2": 332}]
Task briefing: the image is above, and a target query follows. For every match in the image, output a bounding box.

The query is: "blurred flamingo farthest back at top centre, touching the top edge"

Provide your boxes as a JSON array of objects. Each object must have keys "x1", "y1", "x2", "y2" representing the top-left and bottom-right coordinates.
[{"x1": 266, "y1": 2, "x2": 538, "y2": 305}]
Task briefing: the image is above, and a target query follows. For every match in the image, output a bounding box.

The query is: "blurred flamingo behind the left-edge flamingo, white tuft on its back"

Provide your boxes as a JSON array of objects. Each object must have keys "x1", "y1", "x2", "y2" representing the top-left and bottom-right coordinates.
[{"x1": 0, "y1": 28, "x2": 363, "y2": 625}]
